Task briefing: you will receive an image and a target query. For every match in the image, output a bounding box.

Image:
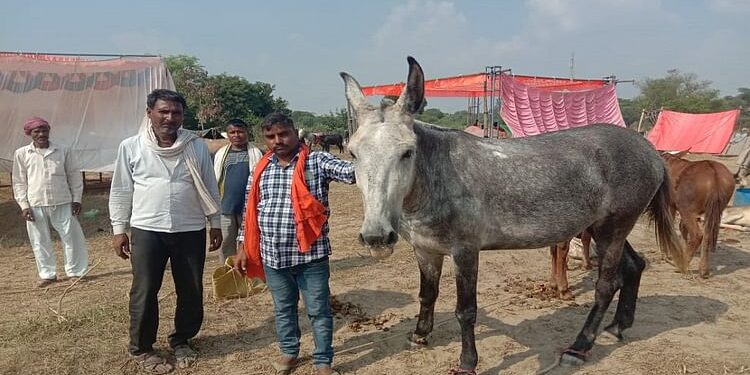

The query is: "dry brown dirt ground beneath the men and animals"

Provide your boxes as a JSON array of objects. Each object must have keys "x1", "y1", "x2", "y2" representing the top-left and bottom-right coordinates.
[{"x1": 0, "y1": 153, "x2": 750, "y2": 375}]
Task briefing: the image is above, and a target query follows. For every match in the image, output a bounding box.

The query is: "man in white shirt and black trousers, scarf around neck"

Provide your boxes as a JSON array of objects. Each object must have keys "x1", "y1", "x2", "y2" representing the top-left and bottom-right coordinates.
[{"x1": 109, "y1": 89, "x2": 222, "y2": 373}]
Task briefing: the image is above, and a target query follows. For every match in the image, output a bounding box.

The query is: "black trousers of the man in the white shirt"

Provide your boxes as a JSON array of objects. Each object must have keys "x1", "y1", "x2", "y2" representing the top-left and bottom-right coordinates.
[{"x1": 129, "y1": 228, "x2": 206, "y2": 355}]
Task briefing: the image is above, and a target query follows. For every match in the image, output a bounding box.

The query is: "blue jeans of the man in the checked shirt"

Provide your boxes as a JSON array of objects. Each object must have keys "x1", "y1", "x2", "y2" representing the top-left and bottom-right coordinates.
[{"x1": 263, "y1": 258, "x2": 333, "y2": 367}]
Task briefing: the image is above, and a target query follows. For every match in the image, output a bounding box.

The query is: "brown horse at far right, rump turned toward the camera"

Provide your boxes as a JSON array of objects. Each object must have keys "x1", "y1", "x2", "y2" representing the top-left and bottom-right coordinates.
[{"x1": 661, "y1": 151, "x2": 734, "y2": 278}]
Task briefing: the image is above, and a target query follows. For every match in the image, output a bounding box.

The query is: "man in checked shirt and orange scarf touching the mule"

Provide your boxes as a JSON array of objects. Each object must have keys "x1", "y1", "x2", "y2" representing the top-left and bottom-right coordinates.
[{"x1": 235, "y1": 113, "x2": 355, "y2": 375}]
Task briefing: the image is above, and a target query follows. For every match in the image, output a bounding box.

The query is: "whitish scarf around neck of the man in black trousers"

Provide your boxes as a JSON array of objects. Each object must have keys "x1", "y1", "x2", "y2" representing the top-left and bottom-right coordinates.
[{"x1": 138, "y1": 117, "x2": 219, "y2": 216}]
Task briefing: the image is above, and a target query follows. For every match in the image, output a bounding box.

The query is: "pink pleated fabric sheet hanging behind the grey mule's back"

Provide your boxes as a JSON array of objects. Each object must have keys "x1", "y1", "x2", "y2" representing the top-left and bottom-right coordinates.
[{"x1": 500, "y1": 75, "x2": 625, "y2": 137}]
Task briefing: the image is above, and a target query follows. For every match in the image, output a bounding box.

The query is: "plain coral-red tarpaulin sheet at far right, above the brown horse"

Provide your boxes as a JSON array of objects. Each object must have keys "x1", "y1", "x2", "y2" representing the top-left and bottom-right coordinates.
[{"x1": 648, "y1": 109, "x2": 740, "y2": 154}]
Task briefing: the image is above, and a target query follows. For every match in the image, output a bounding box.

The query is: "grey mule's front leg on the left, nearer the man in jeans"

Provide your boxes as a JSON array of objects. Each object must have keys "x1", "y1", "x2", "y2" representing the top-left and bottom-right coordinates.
[{"x1": 409, "y1": 248, "x2": 444, "y2": 346}]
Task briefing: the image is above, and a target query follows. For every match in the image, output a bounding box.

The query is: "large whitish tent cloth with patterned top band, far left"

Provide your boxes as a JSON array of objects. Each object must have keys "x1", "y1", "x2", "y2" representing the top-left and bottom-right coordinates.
[{"x1": 0, "y1": 53, "x2": 174, "y2": 172}]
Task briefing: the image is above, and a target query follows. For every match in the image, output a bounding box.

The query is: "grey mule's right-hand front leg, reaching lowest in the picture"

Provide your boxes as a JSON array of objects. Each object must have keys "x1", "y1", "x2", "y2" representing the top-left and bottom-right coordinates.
[{"x1": 452, "y1": 248, "x2": 479, "y2": 374}]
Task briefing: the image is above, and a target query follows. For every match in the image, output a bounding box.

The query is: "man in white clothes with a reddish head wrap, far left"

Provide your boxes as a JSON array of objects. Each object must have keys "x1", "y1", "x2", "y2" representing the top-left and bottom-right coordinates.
[{"x1": 13, "y1": 117, "x2": 89, "y2": 288}]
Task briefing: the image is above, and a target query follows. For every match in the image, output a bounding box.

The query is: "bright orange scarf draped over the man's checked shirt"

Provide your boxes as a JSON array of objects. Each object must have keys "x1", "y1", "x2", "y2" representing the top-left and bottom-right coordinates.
[{"x1": 243, "y1": 144, "x2": 328, "y2": 280}]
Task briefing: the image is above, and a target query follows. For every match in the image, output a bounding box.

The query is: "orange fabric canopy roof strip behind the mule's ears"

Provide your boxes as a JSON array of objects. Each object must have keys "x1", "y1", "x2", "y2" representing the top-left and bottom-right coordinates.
[{"x1": 362, "y1": 73, "x2": 607, "y2": 98}]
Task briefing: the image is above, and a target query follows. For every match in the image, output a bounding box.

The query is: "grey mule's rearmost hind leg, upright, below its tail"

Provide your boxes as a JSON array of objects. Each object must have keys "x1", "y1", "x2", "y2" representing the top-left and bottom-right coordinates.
[{"x1": 604, "y1": 240, "x2": 646, "y2": 341}]
